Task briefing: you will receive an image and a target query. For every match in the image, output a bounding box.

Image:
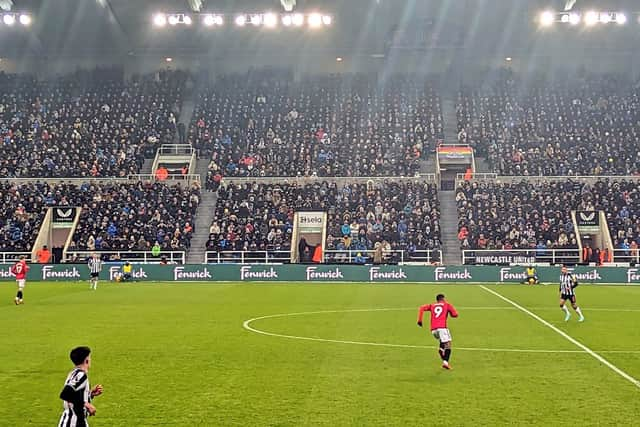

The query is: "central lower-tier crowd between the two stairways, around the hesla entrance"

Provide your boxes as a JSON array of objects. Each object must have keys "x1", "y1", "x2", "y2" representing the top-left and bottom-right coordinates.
[{"x1": 206, "y1": 181, "x2": 440, "y2": 262}]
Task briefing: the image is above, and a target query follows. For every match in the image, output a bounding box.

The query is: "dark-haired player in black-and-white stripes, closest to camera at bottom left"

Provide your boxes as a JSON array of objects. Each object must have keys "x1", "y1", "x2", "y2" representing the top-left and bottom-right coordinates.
[{"x1": 58, "y1": 347, "x2": 102, "y2": 427}]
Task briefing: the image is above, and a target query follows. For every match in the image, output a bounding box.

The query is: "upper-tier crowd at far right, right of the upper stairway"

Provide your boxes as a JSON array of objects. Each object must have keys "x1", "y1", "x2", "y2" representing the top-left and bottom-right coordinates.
[{"x1": 457, "y1": 70, "x2": 640, "y2": 176}]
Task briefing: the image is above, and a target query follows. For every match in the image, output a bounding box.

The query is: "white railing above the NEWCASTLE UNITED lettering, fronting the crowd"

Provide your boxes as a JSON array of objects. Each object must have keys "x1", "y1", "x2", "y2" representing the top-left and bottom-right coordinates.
[{"x1": 462, "y1": 248, "x2": 580, "y2": 265}]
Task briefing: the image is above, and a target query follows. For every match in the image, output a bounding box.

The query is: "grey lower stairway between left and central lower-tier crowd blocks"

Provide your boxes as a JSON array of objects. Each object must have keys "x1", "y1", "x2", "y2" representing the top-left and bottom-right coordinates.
[{"x1": 187, "y1": 159, "x2": 218, "y2": 264}]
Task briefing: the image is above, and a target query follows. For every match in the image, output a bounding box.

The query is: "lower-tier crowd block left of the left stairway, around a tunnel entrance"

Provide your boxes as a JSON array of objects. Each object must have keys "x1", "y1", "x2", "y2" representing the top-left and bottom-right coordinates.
[{"x1": 0, "y1": 182, "x2": 200, "y2": 258}]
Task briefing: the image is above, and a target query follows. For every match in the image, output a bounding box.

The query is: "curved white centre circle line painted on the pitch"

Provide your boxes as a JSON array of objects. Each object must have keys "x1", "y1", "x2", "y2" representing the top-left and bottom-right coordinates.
[{"x1": 242, "y1": 307, "x2": 640, "y2": 354}]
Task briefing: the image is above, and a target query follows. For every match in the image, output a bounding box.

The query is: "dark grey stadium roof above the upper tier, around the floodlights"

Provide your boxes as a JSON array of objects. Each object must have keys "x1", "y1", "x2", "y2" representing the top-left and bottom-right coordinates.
[{"x1": 0, "y1": 0, "x2": 640, "y2": 57}]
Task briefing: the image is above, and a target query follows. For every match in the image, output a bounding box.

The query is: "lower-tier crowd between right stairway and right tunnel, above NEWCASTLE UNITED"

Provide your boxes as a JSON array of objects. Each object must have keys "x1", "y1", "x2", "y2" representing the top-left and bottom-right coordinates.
[{"x1": 456, "y1": 181, "x2": 584, "y2": 262}]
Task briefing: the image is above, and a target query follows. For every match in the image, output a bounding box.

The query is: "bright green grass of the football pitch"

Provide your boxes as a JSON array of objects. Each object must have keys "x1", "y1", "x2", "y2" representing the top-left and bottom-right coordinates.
[{"x1": 0, "y1": 283, "x2": 640, "y2": 427}]
